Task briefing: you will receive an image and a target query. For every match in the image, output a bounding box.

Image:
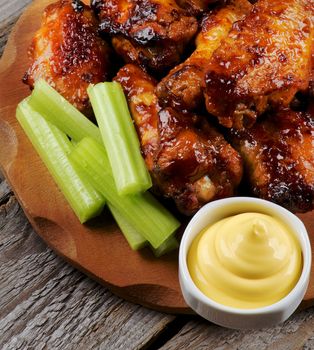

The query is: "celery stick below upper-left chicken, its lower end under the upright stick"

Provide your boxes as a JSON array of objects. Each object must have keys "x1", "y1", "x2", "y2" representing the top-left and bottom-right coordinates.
[{"x1": 29, "y1": 79, "x2": 102, "y2": 143}]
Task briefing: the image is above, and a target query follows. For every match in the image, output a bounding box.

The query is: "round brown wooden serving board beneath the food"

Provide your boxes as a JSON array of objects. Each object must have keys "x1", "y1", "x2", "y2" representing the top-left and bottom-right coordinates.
[{"x1": 0, "y1": 0, "x2": 314, "y2": 313}]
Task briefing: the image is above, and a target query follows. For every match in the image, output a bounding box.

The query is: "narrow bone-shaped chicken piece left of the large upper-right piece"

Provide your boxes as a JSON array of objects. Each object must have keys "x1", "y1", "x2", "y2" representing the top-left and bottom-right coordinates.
[{"x1": 157, "y1": 0, "x2": 252, "y2": 111}]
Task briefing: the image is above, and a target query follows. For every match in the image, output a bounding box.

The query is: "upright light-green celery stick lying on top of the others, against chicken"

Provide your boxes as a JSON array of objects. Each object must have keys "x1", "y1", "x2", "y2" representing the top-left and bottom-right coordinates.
[{"x1": 87, "y1": 82, "x2": 152, "y2": 195}]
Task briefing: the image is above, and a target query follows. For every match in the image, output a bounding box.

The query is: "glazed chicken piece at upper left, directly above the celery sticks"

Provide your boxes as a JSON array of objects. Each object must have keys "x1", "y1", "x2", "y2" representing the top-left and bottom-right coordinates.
[{"x1": 23, "y1": 0, "x2": 110, "y2": 112}]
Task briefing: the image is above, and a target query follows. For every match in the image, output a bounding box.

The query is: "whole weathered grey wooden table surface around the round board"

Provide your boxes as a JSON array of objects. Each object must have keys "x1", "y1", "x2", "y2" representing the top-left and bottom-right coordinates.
[{"x1": 0, "y1": 0, "x2": 314, "y2": 350}]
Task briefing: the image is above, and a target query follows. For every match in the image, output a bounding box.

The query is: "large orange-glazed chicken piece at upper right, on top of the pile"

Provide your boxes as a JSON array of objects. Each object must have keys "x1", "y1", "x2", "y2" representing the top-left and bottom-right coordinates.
[{"x1": 205, "y1": 0, "x2": 314, "y2": 129}]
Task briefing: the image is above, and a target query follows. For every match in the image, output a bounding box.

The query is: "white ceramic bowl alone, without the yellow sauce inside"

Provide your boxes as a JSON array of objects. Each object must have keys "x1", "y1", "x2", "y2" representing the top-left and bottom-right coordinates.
[{"x1": 179, "y1": 197, "x2": 311, "y2": 329}]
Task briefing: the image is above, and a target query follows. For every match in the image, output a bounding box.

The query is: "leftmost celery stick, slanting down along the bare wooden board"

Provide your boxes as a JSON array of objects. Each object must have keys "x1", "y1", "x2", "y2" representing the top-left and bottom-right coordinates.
[{"x1": 16, "y1": 100, "x2": 105, "y2": 223}]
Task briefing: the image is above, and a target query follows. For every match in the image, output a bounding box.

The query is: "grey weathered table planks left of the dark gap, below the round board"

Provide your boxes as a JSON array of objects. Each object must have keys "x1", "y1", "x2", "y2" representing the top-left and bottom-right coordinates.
[{"x1": 0, "y1": 182, "x2": 174, "y2": 349}]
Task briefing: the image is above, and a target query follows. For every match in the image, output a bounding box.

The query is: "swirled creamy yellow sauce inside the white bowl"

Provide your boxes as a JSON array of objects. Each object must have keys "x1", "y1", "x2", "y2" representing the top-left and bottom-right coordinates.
[{"x1": 187, "y1": 213, "x2": 303, "y2": 309}]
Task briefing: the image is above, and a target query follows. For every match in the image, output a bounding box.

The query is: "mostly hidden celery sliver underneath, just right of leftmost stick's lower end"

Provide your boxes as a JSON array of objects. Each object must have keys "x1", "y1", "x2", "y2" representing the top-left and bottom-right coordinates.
[{"x1": 108, "y1": 203, "x2": 147, "y2": 250}]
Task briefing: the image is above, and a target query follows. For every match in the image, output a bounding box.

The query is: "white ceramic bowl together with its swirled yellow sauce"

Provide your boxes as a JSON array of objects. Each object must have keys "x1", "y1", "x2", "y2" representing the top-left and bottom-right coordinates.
[{"x1": 179, "y1": 197, "x2": 312, "y2": 329}]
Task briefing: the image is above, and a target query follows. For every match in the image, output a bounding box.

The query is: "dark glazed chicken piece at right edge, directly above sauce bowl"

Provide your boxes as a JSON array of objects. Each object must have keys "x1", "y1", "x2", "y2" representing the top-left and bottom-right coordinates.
[{"x1": 233, "y1": 104, "x2": 314, "y2": 212}]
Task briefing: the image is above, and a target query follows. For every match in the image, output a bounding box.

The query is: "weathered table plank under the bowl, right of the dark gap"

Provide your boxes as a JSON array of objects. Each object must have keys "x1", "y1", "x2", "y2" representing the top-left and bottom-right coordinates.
[{"x1": 161, "y1": 314, "x2": 314, "y2": 350}]
